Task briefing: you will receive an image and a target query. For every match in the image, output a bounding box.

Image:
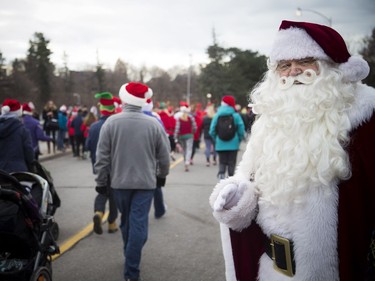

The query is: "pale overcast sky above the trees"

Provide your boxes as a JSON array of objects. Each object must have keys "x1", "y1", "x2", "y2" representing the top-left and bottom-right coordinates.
[{"x1": 0, "y1": 0, "x2": 375, "y2": 70}]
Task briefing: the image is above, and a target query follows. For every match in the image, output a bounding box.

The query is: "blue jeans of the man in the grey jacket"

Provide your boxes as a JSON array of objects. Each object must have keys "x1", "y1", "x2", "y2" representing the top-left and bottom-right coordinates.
[{"x1": 113, "y1": 189, "x2": 154, "y2": 279}]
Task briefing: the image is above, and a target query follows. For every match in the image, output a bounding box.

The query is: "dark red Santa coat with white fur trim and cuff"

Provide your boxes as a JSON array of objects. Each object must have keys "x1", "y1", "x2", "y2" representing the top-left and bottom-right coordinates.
[{"x1": 210, "y1": 85, "x2": 375, "y2": 281}]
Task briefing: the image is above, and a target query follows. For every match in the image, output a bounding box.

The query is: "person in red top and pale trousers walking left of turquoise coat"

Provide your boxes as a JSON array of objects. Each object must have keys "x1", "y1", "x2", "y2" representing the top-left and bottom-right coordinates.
[{"x1": 174, "y1": 102, "x2": 197, "y2": 172}]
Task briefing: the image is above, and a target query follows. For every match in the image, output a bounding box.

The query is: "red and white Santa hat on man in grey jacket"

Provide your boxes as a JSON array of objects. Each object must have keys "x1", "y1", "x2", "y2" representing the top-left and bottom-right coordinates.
[{"x1": 119, "y1": 82, "x2": 153, "y2": 107}]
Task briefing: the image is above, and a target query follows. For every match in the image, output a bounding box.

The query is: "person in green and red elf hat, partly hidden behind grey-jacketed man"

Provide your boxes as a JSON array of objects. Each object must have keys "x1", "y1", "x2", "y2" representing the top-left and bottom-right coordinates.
[{"x1": 86, "y1": 92, "x2": 118, "y2": 235}]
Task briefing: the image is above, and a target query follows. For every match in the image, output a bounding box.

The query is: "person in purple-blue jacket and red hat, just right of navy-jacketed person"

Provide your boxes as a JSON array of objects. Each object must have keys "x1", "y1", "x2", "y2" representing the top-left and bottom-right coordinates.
[{"x1": 22, "y1": 103, "x2": 53, "y2": 160}]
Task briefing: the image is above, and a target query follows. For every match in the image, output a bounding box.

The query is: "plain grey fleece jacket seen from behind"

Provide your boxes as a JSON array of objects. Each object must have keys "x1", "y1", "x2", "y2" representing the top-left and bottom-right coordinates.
[{"x1": 95, "y1": 105, "x2": 170, "y2": 189}]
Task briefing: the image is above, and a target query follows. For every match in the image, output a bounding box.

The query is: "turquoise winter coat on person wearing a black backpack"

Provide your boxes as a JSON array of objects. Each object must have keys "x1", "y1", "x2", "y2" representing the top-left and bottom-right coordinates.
[{"x1": 209, "y1": 105, "x2": 245, "y2": 151}]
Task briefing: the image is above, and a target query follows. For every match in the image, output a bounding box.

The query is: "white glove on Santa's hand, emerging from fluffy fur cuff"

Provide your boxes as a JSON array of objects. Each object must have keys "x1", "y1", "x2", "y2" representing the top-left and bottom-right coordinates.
[{"x1": 213, "y1": 182, "x2": 246, "y2": 211}]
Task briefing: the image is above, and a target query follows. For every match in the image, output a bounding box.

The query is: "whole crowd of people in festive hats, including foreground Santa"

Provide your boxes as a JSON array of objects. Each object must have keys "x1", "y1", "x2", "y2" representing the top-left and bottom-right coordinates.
[{"x1": 0, "y1": 21, "x2": 375, "y2": 281}]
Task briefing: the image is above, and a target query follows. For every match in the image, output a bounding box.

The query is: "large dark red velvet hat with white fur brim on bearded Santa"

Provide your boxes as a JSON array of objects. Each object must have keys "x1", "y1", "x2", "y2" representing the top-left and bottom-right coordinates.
[{"x1": 270, "y1": 20, "x2": 370, "y2": 82}]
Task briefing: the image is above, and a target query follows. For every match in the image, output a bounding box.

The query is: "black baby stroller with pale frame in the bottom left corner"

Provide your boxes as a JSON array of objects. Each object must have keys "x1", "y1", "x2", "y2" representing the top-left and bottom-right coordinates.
[{"x1": 0, "y1": 170, "x2": 59, "y2": 281}]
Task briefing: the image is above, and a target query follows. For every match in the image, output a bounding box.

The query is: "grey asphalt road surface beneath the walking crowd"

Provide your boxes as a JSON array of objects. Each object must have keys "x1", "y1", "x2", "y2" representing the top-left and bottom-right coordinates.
[{"x1": 37, "y1": 141, "x2": 232, "y2": 281}]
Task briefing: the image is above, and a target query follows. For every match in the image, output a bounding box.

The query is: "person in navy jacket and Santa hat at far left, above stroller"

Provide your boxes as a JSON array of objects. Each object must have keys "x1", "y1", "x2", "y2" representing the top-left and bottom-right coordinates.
[{"x1": 0, "y1": 99, "x2": 34, "y2": 173}]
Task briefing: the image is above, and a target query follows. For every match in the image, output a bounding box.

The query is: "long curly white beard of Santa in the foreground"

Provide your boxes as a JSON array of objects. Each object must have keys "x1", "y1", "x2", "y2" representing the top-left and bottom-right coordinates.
[{"x1": 242, "y1": 63, "x2": 354, "y2": 204}]
